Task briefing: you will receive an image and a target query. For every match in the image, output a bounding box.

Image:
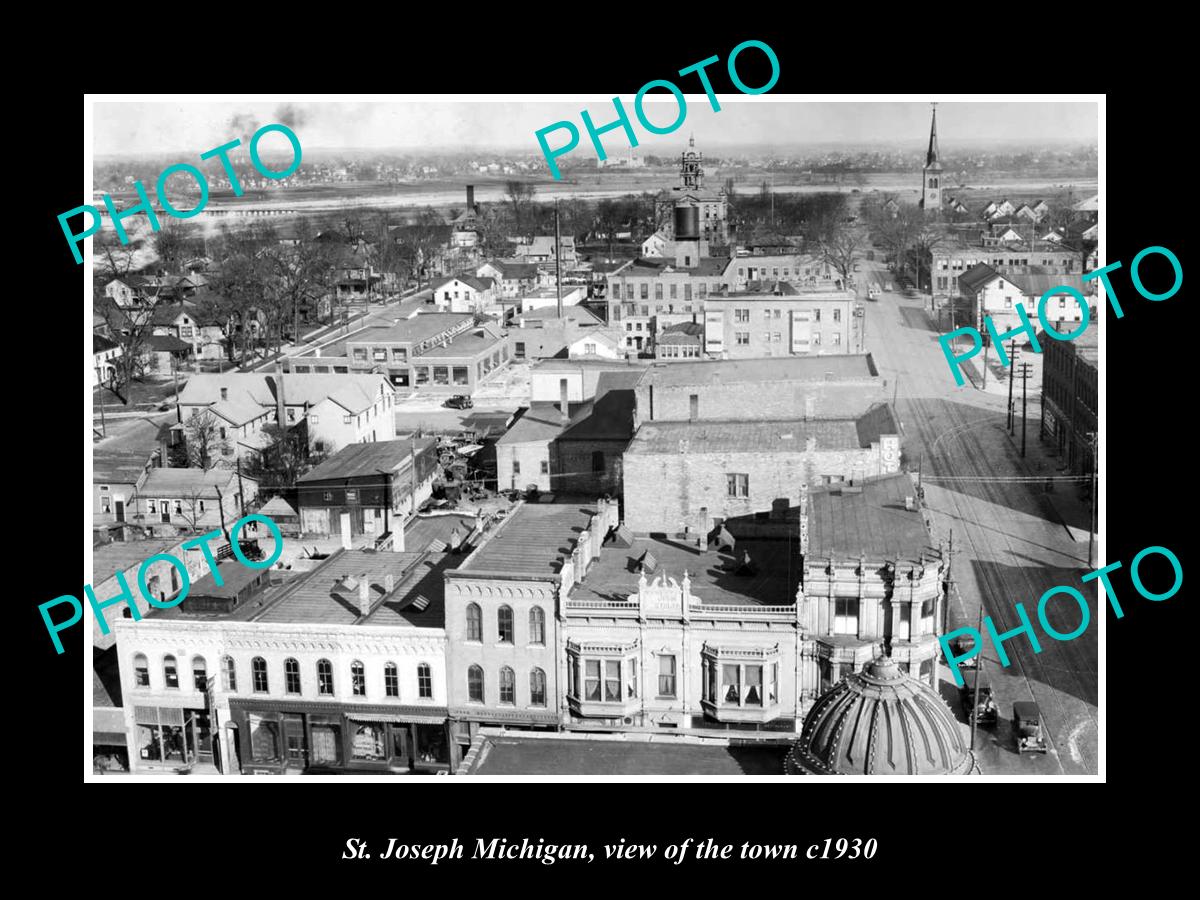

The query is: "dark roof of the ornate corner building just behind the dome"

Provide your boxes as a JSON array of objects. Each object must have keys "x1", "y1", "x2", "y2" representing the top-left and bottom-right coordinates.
[{"x1": 809, "y1": 473, "x2": 941, "y2": 558}]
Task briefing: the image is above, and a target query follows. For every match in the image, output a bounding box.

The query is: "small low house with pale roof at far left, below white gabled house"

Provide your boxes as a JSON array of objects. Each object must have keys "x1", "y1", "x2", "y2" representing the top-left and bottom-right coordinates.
[{"x1": 132, "y1": 468, "x2": 258, "y2": 535}]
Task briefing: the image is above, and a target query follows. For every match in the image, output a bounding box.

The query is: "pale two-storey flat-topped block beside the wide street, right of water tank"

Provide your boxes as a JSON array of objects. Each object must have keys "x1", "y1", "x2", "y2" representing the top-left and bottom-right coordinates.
[{"x1": 704, "y1": 283, "x2": 865, "y2": 359}]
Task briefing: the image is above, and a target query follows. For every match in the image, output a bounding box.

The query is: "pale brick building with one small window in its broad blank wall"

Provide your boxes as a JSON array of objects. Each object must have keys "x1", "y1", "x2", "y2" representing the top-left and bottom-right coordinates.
[{"x1": 623, "y1": 403, "x2": 900, "y2": 534}]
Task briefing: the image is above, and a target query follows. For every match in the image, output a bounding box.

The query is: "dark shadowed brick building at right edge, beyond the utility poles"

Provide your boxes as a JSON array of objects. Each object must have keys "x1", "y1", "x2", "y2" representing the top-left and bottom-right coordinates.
[{"x1": 1039, "y1": 326, "x2": 1100, "y2": 474}]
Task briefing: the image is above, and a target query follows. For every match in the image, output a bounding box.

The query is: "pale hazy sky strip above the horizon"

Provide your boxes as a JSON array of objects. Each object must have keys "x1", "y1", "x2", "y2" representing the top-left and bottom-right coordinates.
[{"x1": 94, "y1": 94, "x2": 1098, "y2": 160}]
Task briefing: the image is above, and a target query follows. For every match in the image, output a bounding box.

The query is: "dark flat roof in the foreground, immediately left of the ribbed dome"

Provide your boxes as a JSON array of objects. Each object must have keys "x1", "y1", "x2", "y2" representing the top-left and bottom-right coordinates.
[{"x1": 467, "y1": 733, "x2": 788, "y2": 775}]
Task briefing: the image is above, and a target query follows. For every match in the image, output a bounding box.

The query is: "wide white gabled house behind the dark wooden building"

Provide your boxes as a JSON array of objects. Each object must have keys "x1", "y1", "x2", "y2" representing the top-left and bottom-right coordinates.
[{"x1": 179, "y1": 371, "x2": 396, "y2": 462}]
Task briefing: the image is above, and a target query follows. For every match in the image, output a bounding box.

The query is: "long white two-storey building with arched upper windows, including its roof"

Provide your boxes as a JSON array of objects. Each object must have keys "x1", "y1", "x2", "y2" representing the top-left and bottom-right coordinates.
[{"x1": 115, "y1": 516, "x2": 475, "y2": 774}]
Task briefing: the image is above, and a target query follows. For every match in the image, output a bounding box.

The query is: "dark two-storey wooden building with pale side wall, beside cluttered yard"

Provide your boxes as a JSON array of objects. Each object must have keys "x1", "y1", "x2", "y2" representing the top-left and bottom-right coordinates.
[{"x1": 296, "y1": 438, "x2": 439, "y2": 535}]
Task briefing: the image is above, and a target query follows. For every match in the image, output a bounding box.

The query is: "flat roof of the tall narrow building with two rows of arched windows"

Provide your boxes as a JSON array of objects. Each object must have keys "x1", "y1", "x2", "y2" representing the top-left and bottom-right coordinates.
[{"x1": 460, "y1": 504, "x2": 596, "y2": 577}]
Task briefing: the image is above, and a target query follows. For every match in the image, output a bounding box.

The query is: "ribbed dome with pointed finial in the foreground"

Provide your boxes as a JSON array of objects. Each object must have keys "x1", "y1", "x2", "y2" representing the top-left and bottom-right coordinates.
[{"x1": 787, "y1": 655, "x2": 972, "y2": 775}]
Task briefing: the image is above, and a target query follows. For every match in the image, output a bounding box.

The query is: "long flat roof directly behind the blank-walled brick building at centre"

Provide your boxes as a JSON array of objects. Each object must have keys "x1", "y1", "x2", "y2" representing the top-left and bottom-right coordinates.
[{"x1": 641, "y1": 353, "x2": 878, "y2": 388}]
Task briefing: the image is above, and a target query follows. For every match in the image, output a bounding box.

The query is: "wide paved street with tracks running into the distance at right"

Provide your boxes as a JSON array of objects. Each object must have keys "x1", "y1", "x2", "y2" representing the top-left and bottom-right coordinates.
[{"x1": 858, "y1": 256, "x2": 1103, "y2": 774}]
